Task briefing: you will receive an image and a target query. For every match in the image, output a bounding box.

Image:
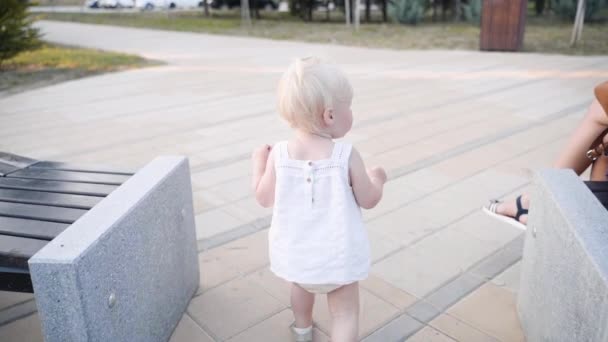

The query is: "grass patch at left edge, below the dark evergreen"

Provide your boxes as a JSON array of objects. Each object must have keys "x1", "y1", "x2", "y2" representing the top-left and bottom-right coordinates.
[{"x1": 0, "y1": 45, "x2": 154, "y2": 97}]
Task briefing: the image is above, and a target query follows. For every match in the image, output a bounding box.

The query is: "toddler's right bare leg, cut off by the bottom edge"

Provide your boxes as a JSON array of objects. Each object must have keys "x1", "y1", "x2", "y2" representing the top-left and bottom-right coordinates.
[{"x1": 327, "y1": 282, "x2": 359, "y2": 342}]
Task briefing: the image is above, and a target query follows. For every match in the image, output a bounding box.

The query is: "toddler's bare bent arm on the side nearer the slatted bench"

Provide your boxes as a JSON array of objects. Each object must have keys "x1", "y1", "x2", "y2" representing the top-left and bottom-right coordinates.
[{"x1": 251, "y1": 145, "x2": 275, "y2": 208}]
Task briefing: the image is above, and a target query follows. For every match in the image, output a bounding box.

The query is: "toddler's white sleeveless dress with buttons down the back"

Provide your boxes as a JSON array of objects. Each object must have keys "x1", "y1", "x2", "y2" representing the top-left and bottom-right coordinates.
[{"x1": 268, "y1": 141, "x2": 371, "y2": 285}]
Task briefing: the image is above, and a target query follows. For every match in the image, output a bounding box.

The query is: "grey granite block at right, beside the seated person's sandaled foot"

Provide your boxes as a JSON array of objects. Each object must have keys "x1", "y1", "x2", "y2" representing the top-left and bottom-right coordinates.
[{"x1": 517, "y1": 170, "x2": 608, "y2": 342}]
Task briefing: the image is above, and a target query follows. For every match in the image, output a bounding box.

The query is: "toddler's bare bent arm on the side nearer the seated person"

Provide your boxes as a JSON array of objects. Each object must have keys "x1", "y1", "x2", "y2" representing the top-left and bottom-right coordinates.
[{"x1": 350, "y1": 148, "x2": 386, "y2": 209}]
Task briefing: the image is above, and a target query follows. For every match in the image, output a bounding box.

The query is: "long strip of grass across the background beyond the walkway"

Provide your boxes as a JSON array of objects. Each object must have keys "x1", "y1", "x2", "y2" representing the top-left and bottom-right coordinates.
[{"x1": 42, "y1": 9, "x2": 608, "y2": 55}]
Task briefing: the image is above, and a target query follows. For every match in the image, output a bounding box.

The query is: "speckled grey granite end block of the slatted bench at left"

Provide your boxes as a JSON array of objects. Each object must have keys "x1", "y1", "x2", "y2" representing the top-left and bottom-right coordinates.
[{"x1": 29, "y1": 157, "x2": 199, "y2": 342}]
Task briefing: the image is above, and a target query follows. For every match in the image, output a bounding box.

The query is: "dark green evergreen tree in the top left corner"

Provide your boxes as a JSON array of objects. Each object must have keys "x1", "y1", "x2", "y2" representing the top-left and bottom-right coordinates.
[{"x1": 0, "y1": 0, "x2": 40, "y2": 66}]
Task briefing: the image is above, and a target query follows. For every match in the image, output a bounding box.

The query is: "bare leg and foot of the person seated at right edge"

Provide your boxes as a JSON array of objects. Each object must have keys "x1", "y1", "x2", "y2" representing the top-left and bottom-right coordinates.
[{"x1": 496, "y1": 100, "x2": 608, "y2": 224}]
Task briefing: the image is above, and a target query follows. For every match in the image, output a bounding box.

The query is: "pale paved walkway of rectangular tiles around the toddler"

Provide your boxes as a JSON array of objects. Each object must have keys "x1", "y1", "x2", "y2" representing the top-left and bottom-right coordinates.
[{"x1": 0, "y1": 22, "x2": 608, "y2": 342}]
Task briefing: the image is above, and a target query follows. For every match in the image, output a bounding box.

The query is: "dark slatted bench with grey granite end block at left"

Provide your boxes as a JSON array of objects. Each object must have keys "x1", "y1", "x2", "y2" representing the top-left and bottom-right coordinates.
[{"x1": 0, "y1": 154, "x2": 199, "y2": 342}]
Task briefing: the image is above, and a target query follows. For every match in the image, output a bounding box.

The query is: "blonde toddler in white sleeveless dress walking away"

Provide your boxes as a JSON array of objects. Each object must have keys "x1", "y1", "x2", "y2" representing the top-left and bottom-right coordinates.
[{"x1": 252, "y1": 58, "x2": 386, "y2": 342}]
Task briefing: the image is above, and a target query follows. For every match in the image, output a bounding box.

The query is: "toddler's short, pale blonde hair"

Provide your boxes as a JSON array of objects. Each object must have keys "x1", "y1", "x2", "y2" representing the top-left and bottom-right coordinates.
[{"x1": 278, "y1": 57, "x2": 353, "y2": 132}]
